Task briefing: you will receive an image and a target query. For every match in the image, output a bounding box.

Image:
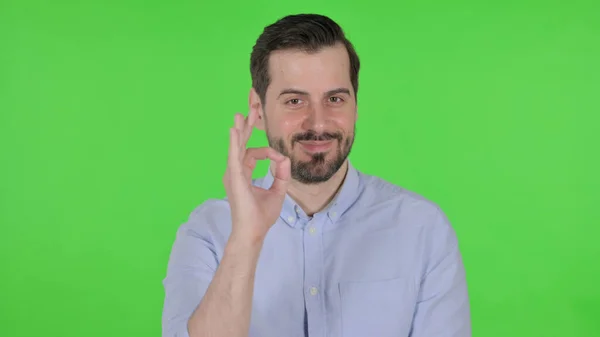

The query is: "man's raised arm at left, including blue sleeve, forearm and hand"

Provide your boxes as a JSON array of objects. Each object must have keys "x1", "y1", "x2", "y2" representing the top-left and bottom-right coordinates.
[{"x1": 163, "y1": 108, "x2": 291, "y2": 337}]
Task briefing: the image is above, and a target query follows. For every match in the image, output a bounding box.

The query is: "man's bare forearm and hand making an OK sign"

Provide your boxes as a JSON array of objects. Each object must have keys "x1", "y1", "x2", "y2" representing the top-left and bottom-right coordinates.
[{"x1": 187, "y1": 112, "x2": 291, "y2": 337}]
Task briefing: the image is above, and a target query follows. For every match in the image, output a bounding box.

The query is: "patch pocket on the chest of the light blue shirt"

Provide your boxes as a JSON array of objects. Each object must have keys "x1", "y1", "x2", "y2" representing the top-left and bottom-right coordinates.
[{"x1": 339, "y1": 278, "x2": 417, "y2": 337}]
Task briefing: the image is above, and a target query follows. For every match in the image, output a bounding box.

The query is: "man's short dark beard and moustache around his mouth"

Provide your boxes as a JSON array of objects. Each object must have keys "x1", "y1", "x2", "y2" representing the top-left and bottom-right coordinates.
[{"x1": 267, "y1": 129, "x2": 356, "y2": 184}]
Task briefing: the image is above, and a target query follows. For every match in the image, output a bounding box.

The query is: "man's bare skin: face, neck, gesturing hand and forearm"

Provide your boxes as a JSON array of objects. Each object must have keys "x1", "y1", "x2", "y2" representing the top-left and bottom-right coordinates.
[{"x1": 188, "y1": 45, "x2": 357, "y2": 337}]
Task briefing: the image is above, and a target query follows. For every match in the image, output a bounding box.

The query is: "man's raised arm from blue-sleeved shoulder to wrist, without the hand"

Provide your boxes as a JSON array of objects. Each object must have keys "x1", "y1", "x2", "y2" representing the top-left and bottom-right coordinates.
[{"x1": 162, "y1": 202, "x2": 262, "y2": 337}]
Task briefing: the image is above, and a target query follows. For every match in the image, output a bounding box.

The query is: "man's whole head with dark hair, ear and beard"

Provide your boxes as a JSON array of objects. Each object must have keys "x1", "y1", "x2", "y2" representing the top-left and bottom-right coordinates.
[{"x1": 249, "y1": 14, "x2": 360, "y2": 184}]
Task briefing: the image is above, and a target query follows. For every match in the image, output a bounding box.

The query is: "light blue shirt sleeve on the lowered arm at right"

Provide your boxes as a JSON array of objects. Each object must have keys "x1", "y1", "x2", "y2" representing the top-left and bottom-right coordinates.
[{"x1": 410, "y1": 210, "x2": 471, "y2": 337}]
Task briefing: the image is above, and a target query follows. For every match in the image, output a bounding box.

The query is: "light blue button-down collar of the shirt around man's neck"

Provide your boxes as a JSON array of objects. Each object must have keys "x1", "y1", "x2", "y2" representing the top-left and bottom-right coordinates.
[{"x1": 260, "y1": 161, "x2": 360, "y2": 227}]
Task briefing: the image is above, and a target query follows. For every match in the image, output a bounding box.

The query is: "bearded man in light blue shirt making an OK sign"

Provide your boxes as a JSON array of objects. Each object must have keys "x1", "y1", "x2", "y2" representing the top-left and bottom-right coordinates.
[{"x1": 163, "y1": 15, "x2": 471, "y2": 337}]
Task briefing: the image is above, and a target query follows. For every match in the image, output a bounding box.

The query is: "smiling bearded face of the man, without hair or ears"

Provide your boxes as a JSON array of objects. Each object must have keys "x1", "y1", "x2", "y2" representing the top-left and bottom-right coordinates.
[{"x1": 262, "y1": 45, "x2": 357, "y2": 184}]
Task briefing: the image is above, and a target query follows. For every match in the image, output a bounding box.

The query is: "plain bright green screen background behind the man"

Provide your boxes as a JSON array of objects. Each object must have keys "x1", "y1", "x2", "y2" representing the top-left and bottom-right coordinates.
[{"x1": 0, "y1": 0, "x2": 600, "y2": 337}]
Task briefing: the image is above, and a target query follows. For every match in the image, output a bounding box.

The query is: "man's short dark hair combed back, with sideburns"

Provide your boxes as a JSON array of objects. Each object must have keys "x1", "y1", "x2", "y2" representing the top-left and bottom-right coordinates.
[{"x1": 250, "y1": 14, "x2": 360, "y2": 106}]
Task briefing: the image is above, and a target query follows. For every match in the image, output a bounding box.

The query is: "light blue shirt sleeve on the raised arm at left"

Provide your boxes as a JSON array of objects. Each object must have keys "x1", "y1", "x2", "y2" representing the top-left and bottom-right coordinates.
[{"x1": 162, "y1": 206, "x2": 223, "y2": 337}]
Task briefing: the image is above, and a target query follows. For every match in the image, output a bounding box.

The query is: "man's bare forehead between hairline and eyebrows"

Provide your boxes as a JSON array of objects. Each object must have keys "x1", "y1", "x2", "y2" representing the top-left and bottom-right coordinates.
[{"x1": 267, "y1": 44, "x2": 352, "y2": 94}]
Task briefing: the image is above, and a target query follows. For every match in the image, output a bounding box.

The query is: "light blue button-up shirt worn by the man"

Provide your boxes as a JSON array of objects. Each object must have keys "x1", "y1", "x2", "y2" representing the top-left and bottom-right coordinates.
[{"x1": 162, "y1": 165, "x2": 471, "y2": 337}]
